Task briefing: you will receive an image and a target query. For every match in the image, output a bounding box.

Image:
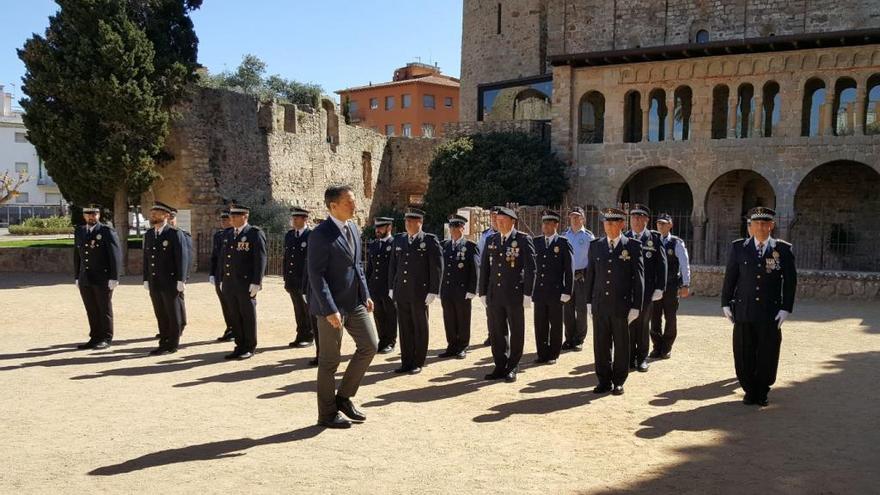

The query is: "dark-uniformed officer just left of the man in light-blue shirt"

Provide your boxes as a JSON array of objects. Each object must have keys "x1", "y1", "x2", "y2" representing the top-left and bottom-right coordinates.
[{"x1": 532, "y1": 210, "x2": 586, "y2": 364}]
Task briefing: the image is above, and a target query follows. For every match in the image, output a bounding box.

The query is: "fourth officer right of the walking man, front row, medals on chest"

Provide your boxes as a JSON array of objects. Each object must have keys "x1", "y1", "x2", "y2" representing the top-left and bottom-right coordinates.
[{"x1": 480, "y1": 207, "x2": 535, "y2": 383}]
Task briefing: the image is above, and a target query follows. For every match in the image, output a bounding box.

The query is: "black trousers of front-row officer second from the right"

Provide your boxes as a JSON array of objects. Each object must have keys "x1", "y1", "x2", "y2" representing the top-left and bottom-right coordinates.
[{"x1": 593, "y1": 312, "x2": 630, "y2": 385}]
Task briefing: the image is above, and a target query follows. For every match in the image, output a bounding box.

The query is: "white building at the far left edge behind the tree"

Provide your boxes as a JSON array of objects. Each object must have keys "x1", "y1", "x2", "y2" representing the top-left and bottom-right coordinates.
[{"x1": 0, "y1": 85, "x2": 65, "y2": 211}]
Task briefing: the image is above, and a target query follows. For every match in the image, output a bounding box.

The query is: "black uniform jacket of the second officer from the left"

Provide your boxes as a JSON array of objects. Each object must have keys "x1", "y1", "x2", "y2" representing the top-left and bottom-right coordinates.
[{"x1": 144, "y1": 225, "x2": 186, "y2": 290}]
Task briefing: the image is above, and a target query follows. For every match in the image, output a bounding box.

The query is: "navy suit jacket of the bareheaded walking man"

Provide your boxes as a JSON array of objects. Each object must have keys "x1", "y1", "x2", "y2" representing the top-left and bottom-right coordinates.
[{"x1": 306, "y1": 217, "x2": 370, "y2": 316}]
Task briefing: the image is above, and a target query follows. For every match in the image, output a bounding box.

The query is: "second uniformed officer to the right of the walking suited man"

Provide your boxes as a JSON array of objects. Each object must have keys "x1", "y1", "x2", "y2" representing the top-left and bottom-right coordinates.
[{"x1": 388, "y1": 208, "x2": 443, "y2": 375}]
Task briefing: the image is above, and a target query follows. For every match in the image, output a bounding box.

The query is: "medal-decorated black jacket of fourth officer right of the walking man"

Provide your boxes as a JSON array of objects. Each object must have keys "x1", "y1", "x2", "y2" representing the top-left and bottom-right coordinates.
[{"x1": 480, "y1": 231, "x2": 535, "y2": 306}]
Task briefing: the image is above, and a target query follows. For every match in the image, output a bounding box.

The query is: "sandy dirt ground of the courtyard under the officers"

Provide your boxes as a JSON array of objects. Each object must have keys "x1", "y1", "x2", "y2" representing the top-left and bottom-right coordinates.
[{"x1": 0, "y1": 274, "x2": 880, "y2": 494}]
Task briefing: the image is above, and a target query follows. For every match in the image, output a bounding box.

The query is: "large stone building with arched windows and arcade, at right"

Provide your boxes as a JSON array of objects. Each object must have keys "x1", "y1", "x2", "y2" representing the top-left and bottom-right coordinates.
[{"x1": 460, "y1": 0, "x2": 880, "y2": 271}]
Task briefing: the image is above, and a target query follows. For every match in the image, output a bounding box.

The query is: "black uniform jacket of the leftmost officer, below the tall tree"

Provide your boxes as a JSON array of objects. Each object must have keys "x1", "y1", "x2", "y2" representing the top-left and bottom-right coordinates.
[{"x1": 73, "y1": 223, "x2": 122, "y2": 287}]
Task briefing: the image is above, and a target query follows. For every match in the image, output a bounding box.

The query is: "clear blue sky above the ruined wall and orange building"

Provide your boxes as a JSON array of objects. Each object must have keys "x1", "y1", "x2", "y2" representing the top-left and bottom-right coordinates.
[{"x1": 0, "y1": 0, "x2": 462, "y2": 105}]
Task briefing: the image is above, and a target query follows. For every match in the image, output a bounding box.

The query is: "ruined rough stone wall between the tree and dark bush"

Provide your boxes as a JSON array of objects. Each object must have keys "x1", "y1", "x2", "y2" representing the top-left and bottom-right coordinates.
[{"x1": 147, "y1": 88, "x2": 437, "y2": 233}]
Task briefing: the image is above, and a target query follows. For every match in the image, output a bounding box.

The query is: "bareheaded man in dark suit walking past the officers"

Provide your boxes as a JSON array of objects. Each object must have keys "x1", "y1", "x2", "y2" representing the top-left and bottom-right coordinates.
[{"x1": 307, "y1": 186, "x2": 379, "y2": 428}]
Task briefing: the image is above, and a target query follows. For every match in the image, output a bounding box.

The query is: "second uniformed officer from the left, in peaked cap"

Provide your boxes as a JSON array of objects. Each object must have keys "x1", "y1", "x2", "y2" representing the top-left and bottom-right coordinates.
[{"x1": 143, "y1": 201, "x2": 186, "y2": 356}]
